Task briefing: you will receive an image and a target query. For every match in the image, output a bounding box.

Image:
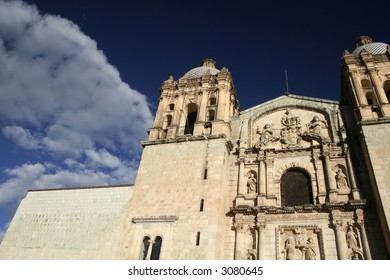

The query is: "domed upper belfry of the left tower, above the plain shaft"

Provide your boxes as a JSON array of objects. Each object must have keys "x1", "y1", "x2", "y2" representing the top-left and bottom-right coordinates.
[{"x1": 149, "y1": 59, "x2": 239, "y2": 140}]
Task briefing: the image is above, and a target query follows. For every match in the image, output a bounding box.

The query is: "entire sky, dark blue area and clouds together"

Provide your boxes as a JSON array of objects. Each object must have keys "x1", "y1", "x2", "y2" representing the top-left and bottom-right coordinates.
[{"x1": 0, "y1": 0, "x2": 390, "y2": 240}]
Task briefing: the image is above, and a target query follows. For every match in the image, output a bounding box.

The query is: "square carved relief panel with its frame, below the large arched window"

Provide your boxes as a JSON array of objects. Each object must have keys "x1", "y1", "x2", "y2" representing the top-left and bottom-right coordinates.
[{"x1": 276, "y1": 226, "x2": 325, "y2": 260}]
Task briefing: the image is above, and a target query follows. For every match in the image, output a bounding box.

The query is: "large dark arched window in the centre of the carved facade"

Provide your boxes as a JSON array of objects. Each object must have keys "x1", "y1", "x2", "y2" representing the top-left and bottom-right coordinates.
[{"x1": 281, "y1": 169, "x2": 313, "y2": 206}]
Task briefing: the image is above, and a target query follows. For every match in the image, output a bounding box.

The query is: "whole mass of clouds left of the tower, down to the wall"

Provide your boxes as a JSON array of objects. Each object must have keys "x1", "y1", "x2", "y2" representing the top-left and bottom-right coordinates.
[{"x1": 0, "y1": 0, "x2": 152, "y2": 211}]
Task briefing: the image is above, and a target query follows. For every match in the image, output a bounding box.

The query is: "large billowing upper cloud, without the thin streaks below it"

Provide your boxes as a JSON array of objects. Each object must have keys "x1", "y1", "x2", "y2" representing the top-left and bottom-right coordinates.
[{"x1": 0, "y1": 1, "x2": 152, "y2": 156}]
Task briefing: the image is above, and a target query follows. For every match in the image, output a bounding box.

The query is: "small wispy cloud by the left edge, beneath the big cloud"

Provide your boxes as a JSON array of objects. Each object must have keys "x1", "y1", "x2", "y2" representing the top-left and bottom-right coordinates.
[{"x1": 2, "y1": 125, "x2": 39, "y2": 150}]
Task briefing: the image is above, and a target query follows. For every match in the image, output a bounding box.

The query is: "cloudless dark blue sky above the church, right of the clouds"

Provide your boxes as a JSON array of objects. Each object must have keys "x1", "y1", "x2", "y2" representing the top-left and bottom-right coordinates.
[{"x1": 28, "y1": 0, "x2": 390, "y2": 110}]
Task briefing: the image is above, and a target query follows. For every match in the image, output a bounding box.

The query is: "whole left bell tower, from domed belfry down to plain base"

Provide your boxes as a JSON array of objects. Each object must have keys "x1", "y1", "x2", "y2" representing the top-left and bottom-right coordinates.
[{"x1": 119, "y1": 59, "x2": 239, "y2": 260}]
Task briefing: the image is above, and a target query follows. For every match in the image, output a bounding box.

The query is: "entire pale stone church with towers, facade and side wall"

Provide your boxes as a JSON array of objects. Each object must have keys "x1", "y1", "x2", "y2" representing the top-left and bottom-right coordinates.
[{"x1": 0, "y1": 36, "x2": 390, "y2": 260}]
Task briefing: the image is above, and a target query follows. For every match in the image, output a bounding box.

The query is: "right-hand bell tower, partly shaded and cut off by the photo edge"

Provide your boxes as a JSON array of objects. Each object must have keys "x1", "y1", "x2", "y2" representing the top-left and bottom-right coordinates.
[{"x1": 340, "y1": 36, "x2": 390, "y2": 254}]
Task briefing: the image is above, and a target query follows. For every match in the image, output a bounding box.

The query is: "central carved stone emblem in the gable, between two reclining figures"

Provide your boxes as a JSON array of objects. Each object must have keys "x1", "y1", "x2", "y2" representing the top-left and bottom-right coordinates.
[{"x1": 280, "y1": 109, "x2": 302, "y2": 149}]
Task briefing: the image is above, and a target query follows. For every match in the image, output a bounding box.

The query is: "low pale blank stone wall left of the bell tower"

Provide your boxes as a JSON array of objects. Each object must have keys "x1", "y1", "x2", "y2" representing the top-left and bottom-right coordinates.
[{"x1": 0, "y1": 186, "x2": 132, "y2": 259}]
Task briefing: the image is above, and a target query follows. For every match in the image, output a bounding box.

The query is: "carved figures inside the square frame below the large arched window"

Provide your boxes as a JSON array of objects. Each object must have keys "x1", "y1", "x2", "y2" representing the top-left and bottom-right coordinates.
[{"x1": 282, "y1": 228, "x2": 319, "y2": 260}]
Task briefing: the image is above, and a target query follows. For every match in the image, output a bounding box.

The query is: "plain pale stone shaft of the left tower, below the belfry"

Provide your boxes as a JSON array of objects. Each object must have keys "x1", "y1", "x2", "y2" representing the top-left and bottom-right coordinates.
[{"x1": 118, "y1": 137, "x2": 229, "y2": 259}]
